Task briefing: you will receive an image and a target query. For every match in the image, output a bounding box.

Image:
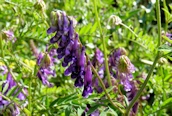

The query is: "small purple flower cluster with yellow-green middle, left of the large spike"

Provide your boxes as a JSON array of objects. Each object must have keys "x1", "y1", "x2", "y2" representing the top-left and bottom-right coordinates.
[{"x1": 37, "y1": 48, "x2": 57, "y2": 87}]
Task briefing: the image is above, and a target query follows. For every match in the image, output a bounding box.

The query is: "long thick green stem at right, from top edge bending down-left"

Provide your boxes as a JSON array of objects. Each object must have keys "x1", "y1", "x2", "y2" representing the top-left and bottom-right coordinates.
[{"x1": 125, "y1": 0, "x2": 161, "y2": 116}]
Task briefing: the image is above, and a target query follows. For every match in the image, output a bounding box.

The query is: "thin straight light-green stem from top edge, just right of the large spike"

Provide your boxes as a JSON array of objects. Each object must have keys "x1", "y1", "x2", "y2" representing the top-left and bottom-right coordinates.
[{"x1": 93, "y1": 0, "x2": 112, "y2": 87}]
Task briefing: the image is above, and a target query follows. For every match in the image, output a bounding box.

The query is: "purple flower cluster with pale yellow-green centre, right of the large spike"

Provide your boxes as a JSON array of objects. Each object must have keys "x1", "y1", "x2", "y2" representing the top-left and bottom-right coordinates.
[{"x1": 109, "y1": 48, "x2": 135, "y2": 91}]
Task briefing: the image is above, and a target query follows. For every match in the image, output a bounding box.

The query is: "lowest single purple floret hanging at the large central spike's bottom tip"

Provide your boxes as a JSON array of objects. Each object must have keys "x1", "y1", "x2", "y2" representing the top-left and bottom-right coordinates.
[{"x1": 82, "y1": 62, "x2": 93, "y2": 97}]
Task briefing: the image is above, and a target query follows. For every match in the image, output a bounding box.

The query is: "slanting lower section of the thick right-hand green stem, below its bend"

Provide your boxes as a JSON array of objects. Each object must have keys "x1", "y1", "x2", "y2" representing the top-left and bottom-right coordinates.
[{"x1": 125, "y1": 53, "x2": 159, "y2": 116}]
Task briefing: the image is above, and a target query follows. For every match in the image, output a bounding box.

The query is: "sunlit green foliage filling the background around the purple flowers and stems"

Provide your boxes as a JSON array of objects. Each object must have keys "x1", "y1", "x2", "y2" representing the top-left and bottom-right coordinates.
[{"x1": 0, "y1": 0, "x2": 172, "y2": 116}]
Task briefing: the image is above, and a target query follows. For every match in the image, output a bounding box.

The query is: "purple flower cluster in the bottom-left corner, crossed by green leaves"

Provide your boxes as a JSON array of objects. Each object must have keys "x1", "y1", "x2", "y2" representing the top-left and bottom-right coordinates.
[{"x1": 0, "y1": 66, "x2": 26, "y2": 116}]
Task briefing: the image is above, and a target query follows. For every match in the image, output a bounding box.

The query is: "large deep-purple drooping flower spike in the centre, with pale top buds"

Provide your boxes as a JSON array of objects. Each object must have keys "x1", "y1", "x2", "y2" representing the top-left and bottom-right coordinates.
[{"x1": 47, "y1": 11, "x2": 93, "y2": 97}]
